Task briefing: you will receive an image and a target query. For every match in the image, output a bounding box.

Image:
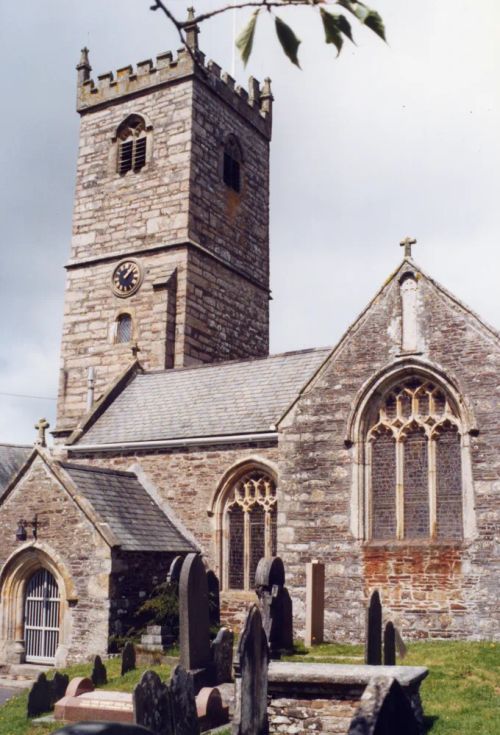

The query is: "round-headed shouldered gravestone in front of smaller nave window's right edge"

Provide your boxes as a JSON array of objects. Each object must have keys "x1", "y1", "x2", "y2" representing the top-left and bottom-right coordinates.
[{"x1": 255, "y1": 556, "x2": 293, "y2": 658}]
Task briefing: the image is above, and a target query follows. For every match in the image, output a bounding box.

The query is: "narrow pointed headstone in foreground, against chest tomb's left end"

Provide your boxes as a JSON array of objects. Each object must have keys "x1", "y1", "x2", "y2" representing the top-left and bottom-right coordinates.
[{"x1": 232, "y1": 605, "x2": 269, "y2": 735}]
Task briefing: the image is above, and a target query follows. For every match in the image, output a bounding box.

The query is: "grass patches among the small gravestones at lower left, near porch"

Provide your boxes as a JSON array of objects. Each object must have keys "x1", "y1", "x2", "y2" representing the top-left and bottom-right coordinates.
[{"x1": 0, "y1": 658, "x2": 170, "y2": 735}]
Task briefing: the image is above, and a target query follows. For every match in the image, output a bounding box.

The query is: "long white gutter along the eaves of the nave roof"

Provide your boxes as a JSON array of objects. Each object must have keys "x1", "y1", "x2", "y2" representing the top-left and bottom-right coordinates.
[{"x1": 62, "y1": 431, "x2": 278, "y2": 454}]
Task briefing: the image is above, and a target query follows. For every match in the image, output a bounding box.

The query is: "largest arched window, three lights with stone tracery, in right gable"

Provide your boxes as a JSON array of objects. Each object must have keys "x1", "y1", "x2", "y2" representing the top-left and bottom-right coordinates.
[{"x1": 366, "y1": 378, "x2": 463, "y2": 540}]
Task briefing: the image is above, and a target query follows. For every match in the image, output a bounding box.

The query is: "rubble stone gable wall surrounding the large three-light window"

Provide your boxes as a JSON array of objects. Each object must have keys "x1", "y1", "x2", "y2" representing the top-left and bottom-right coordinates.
[{"x1": 278, "y1": 266, "x2": 500, "y2": 641}]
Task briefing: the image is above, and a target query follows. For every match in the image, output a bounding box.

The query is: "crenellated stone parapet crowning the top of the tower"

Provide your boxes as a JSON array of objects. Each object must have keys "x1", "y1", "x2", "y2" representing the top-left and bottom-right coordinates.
[{"x1": 76, "y1": 48, "x2": 273, "y2": 138}]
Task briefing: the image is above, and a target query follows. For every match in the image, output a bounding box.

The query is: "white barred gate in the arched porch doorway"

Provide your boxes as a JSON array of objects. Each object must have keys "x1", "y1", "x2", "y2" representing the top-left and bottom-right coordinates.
[{"x1": 24, "y1": 569, "x2": 60, "y2": 664}]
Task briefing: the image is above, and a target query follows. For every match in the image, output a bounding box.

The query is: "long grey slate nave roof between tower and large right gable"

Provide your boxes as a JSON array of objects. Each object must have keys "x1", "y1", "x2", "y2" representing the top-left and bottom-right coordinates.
[{"x1": 76, "y1": 348, "x2": 330, "y2": 446}]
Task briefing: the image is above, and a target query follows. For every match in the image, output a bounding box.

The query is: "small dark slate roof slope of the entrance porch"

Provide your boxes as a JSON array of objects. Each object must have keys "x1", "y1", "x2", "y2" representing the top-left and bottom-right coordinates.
[{"x1": 59, "y1": 462, "x2": 196, "y2": 553}]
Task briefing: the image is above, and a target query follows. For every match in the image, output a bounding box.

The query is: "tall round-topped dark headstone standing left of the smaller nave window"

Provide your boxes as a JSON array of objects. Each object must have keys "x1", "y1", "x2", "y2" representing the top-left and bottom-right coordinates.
[{"x1": 179, "y1": 554, "x2": 210, "y2": 671}]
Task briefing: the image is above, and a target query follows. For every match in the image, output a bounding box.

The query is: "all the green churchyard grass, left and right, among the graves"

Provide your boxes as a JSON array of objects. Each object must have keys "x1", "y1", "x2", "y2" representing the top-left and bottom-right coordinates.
[{"x1": 0, "y1": 641, "x2": 500, "y2": 735}]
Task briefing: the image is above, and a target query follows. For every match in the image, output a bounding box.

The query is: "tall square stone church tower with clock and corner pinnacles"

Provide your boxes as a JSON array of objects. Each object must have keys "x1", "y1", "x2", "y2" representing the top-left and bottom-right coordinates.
[{"x1": 54, "y1": 26, "x2": 272, "y2": 440}]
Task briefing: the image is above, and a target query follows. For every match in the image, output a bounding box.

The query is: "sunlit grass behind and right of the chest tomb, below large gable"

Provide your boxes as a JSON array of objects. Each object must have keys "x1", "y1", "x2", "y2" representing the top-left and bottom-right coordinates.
[{"x1": 288, "y1": 641, "x2": 500, "y2": 735}]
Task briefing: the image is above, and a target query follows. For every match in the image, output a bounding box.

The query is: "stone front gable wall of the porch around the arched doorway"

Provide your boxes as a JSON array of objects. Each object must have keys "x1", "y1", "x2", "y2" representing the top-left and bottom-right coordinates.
[{"x1": 0, "y1": 458, "x2": 111, "y2": 662}]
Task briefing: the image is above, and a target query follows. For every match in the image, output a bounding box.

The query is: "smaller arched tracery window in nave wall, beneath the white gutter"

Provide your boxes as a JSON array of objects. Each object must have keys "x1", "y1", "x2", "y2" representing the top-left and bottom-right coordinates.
[{"x1": 222, "y1": 469, "x2": 277, "y2": 590}]
